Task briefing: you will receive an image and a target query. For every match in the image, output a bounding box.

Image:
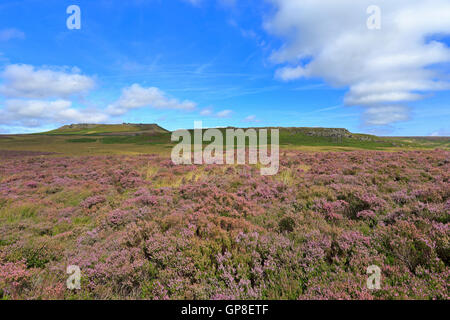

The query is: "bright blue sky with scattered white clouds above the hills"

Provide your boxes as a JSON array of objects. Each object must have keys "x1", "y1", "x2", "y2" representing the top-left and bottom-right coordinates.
[{"x1": 0, "y1": 0, "x2": 450, "y2": 135}]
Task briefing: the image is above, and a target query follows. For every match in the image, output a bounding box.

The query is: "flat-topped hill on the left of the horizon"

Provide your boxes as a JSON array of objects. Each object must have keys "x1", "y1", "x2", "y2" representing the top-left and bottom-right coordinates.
[{"x1": 39, "y1": 123, "x2": 169, "y2": 136}]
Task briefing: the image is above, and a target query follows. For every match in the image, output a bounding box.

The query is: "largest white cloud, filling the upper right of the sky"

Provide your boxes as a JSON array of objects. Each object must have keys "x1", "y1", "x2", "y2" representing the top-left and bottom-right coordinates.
[{"x1": 266, "y1": 0, "x2": 450, "y2": 125}]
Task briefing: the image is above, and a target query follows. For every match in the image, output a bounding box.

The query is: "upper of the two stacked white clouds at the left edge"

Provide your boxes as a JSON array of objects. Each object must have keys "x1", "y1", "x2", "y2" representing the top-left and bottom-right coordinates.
[{"x1": 0, "y1": 64, "x2": 95, "y2": 99}]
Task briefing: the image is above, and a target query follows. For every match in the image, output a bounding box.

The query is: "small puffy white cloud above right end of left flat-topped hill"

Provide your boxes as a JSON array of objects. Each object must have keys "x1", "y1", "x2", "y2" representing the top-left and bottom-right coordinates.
[{"x1": 107, "y1": 83, "x2": 196, "y2": 116}]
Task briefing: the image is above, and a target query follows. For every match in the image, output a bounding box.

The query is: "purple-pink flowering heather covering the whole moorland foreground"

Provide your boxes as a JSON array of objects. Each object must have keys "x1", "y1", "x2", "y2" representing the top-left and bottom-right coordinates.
[{"x1": 0, "y1": 150, "x2": 450, "y2": 300}]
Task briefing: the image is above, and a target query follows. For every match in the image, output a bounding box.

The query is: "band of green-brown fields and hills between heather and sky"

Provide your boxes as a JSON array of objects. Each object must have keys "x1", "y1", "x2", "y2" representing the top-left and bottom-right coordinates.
[{"x1": 0, "y1": 124, "x2": 450, "y2": 155}]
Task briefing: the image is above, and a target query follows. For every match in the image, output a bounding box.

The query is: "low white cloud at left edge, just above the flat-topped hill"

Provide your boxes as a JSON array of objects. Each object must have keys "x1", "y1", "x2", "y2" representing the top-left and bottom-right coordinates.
[{"x1": 0, "y1": 99, "x2": 108, "y2": 126}]
